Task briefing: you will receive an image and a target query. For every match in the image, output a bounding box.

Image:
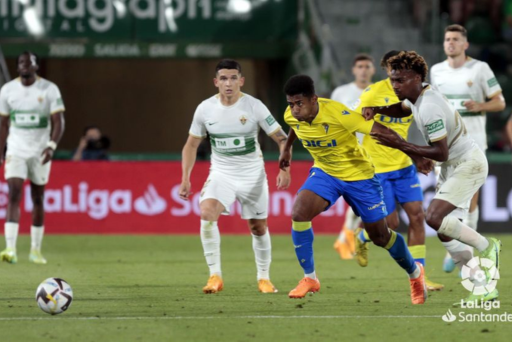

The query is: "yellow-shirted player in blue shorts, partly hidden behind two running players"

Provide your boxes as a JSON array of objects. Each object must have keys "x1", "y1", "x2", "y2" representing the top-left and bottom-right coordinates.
[{"x1": 348, "y1": 50, "x2": 444, "y2": 291}]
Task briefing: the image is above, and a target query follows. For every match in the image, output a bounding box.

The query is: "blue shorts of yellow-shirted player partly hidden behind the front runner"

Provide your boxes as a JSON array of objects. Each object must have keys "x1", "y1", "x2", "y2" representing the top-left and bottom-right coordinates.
[{"x1": 376, "y1": 165, "x2": 423, "y2": 214}]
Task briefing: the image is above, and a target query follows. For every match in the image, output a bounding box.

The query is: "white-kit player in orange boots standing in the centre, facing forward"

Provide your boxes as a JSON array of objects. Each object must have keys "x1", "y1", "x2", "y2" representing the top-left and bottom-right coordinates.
[{"x1": 180, "y1": 59, "x2": 290, "y2": 293}]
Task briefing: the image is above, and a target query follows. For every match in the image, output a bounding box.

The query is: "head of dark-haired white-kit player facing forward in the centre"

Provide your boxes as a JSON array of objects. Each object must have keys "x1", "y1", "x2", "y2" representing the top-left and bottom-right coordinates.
[{"x1": 213, "y1": 59, "x2": 245, "y2": 98}]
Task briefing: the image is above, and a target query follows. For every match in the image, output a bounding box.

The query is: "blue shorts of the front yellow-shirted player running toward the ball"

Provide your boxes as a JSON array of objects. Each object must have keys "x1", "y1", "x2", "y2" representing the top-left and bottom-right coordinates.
[{"x1": 298, "y1": 167, "x2": 388, "y2": 223}]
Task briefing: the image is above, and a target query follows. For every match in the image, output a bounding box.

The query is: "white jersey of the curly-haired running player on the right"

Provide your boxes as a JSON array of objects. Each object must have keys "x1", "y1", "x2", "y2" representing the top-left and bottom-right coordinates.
[{"x1": 411, "y1": 83, "x2": 475, "y2": 164}]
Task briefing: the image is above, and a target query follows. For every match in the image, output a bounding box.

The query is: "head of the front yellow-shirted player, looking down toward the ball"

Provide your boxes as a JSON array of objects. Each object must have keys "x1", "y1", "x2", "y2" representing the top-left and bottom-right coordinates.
[{"x1": 284, "y1": 75, "x2": 318, "y2": 121}]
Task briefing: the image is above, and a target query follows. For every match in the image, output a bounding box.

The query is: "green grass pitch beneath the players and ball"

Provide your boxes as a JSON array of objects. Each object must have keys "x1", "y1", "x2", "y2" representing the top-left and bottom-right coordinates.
[{"x1": 0, "y1": 235, "x2": 512, "y2": 342}]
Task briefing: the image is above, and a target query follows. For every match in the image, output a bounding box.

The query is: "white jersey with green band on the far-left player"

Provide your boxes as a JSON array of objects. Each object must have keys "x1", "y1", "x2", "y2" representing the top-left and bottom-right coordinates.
[{"x1": 0, "y1": 77, "x2": 64, "y2": 158}]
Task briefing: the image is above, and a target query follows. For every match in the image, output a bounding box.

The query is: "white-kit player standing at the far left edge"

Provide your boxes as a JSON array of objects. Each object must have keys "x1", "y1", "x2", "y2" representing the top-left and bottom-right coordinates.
[{"x1": 0, "y1": 52, "x2": 64, "y2": 264}]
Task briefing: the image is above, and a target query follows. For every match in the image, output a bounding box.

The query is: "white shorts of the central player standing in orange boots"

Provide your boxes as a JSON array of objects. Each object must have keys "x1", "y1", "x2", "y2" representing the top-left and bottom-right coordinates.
[{"x1": 199, "y1": 168, "x2": 268, "y2": 220}]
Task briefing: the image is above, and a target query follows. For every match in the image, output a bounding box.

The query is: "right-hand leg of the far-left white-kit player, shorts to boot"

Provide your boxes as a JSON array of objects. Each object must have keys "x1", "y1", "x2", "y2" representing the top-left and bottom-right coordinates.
[{"x1": 27, "y1": 158, "x2": 51, "y2": 264}]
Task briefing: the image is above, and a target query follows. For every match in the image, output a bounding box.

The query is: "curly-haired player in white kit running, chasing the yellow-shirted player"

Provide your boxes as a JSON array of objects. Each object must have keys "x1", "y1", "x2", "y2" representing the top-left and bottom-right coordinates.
[{"x1": 363, "y1": 51, "x2": 501, "y2": 301}]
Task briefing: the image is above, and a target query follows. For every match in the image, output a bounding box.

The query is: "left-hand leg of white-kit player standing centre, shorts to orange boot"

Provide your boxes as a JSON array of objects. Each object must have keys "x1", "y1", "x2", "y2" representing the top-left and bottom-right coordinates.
[{"x1": 199, "y1": 172, "x2": 235, "y2": 293}]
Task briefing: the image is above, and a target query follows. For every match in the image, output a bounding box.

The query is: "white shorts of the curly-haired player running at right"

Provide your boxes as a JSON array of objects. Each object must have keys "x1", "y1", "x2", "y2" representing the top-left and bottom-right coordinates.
[{"x1": 434, "y1": 146, "x2": 489, "y2": 219}]
